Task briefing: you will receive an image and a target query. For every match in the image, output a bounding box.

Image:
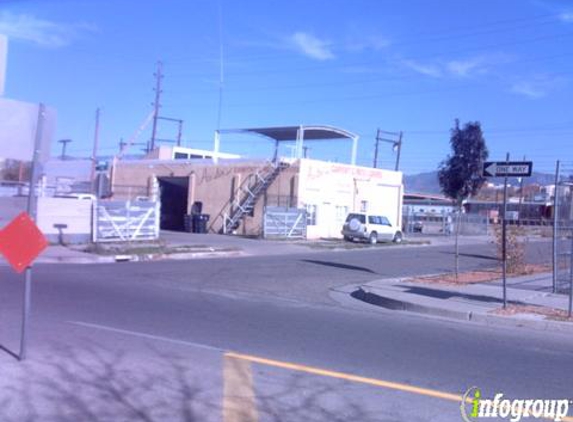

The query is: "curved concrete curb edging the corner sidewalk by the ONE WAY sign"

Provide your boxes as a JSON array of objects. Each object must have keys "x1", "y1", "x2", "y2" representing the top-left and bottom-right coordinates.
[{"x1": 350, "y1": 286, "x2": 573, "y2": 333}]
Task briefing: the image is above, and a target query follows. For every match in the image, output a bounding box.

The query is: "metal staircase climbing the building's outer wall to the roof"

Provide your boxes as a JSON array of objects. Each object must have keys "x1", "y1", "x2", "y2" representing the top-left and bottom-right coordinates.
[{"x1": 211, "y1": 162, "x2": 289, "y2": 234}]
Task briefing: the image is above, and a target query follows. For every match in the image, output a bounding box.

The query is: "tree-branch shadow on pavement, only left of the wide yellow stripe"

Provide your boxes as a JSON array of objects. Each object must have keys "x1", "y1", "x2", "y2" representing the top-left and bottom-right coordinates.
[{"x1": 0, "y1": 344, "x2": 213, "y2": 422}]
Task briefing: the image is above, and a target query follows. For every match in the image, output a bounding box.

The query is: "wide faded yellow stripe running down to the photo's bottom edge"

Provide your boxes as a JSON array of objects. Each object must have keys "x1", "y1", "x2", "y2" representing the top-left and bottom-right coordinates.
[{"x1": 223, "y1": 354, "x2": 259, "y2": 422}]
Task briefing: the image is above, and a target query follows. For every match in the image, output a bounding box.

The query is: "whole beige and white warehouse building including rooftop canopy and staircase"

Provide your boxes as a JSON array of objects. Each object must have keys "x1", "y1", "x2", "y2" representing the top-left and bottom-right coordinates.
[{"x1": 111, "y1": 126, "x2": 403, "y2": 239}]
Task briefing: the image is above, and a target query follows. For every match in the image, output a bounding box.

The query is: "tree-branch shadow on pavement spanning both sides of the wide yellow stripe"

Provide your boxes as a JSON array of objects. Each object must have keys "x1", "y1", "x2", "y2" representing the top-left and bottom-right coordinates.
[{"x1": 0, "y1": 343, "x2": 399, "y2": 422}]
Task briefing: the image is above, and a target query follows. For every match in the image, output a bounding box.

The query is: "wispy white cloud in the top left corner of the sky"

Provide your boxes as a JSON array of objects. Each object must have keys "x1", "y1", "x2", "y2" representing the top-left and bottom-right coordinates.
[{"x1": 0, "y1": 12, "x2": 95, "y2": 48}]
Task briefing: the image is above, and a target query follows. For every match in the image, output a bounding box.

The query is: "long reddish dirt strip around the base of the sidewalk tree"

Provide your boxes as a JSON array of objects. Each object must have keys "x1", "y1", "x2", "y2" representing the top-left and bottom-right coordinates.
[{"x1": 403, "y1": 264, "x2": 551, "y2": 286}]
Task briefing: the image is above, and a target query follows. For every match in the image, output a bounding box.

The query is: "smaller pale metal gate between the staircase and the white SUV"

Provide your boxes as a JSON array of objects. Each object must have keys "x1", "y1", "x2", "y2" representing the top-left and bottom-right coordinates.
[{"x1": 263, "y1": 207, "x2": 306, "y2": 239}]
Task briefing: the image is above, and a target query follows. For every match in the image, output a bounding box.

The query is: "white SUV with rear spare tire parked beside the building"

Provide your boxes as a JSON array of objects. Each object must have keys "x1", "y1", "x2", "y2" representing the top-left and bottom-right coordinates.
[{"x1": 342, "y1": 212, "x2": 403, "y2": 244}]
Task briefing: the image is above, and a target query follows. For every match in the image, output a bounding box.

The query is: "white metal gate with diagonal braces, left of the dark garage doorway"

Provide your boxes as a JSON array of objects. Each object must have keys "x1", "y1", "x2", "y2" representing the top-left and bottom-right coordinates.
[{"x1": 92, "y1": 201, "x2": 160, "y2": 242}]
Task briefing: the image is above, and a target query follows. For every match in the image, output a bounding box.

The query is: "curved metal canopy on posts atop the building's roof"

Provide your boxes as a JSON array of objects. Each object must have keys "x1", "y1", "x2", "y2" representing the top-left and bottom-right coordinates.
[{"x1": 213, "y1": 125, "x2": 358, "y2": 165}]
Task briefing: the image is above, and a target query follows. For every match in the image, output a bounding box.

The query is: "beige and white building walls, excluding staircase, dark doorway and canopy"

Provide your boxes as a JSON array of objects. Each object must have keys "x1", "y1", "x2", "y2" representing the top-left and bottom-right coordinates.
[{"x1": 112, "y1": 159, "x2": 403, "y2": 239}]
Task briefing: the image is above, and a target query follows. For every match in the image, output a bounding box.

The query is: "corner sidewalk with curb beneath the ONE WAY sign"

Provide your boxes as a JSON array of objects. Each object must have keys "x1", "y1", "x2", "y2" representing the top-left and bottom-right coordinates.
[{"x1": 352, "y1": 274, "x2": 573, "y2": 333}]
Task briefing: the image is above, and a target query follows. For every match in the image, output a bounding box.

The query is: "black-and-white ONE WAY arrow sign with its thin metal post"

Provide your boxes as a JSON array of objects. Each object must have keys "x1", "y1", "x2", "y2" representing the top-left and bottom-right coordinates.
[{"x1": 482, "y1": 157, "x2": 533, "y2": 309}]
